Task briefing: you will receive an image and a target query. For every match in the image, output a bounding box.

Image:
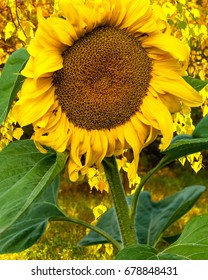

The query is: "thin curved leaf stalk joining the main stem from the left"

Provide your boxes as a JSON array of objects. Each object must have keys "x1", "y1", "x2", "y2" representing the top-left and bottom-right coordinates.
[{"x1": 53, "y1": 213, "x2": 122, "y2": 251}]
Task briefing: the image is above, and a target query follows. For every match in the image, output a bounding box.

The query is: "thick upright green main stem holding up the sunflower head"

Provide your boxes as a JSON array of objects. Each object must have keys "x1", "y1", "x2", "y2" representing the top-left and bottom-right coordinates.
[{"x1": 102, "y1": 156, "x2": 138, "y2": 247}]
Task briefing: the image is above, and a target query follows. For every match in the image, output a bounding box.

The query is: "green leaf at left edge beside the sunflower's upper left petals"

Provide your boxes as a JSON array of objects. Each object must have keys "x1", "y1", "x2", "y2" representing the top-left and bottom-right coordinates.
[{"x1": 0, "y1": 48, "x2": 29, "y2": 125}]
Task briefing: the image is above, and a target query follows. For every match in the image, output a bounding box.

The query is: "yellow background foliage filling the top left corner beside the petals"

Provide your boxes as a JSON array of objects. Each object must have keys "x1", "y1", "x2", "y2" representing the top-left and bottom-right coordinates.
[{"x1": 0, "y1": 0, "x2": 54, "y2": 67}]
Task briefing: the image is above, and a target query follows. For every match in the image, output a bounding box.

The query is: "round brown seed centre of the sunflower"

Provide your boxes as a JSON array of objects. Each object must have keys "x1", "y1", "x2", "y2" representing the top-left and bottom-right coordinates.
[{"x1": 53, "y1": 26, "x2": 152, "y2": 130}]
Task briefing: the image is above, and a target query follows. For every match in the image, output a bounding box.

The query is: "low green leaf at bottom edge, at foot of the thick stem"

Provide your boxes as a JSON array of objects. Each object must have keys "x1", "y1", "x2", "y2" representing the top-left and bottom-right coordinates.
[{"x1": 115, "y1": 244, "x2": 186, "y2": 260}]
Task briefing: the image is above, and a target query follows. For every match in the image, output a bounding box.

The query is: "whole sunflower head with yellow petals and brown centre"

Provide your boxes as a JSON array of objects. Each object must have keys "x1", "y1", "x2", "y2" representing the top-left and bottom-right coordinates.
[{"x1": 13, "y1": 0, "x2": 201, "y2": 181}]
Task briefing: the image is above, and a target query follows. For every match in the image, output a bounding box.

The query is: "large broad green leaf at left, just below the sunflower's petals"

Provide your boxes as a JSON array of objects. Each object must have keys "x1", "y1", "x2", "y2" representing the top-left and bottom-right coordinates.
[{"x1": 0, "y1": 140, "x2": 68, "y2": 233}]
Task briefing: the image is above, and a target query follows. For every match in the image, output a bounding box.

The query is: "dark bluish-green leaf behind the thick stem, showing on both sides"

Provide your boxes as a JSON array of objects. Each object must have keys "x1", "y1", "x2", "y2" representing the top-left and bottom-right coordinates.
[{"x1": 79, "y1": 186, "x2": 206, "y2": 246}]
